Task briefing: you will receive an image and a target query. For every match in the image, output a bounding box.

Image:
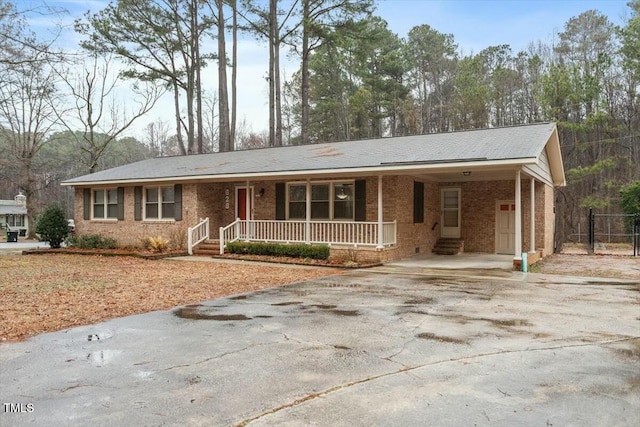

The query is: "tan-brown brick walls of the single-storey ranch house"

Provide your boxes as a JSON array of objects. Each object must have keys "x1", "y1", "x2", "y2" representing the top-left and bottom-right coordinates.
[{"x1": 75, "y1": 176, "x2": 554, "y2": 261}]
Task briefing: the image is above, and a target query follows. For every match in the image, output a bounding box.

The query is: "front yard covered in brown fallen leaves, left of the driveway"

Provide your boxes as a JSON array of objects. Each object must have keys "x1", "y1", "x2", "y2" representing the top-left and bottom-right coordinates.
[{"x1": 0, "y1": 254, "x2": 341, "y2": 341}]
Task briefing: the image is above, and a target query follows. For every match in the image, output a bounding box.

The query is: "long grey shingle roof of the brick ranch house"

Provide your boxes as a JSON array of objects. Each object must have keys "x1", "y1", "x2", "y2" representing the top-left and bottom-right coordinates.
[{"x1": 64, "y1": 123, "x2": 555, "y2": 185}]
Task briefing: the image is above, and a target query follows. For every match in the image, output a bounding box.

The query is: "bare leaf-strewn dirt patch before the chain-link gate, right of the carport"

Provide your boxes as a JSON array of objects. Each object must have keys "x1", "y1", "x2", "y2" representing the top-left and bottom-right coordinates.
[{"x1": 531, "y1": 254, "x2": 640, "y2": 281}]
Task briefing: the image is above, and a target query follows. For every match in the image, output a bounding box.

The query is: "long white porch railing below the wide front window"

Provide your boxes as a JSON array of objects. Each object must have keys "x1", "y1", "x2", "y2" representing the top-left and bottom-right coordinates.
[{"x1": 220, "y1": 218, "x2": 397, "y2": 254}]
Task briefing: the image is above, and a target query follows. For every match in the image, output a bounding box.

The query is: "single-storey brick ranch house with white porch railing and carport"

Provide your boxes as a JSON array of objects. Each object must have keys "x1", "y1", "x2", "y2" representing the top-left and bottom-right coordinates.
[{"x1": 63, "y1": 123, "x2": 565, "y2": 263}]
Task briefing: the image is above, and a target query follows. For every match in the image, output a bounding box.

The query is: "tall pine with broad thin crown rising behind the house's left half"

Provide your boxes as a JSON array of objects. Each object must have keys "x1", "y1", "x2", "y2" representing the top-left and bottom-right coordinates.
[{"x1": 76, "y1": 0, "x2": 213, "y2": 154}]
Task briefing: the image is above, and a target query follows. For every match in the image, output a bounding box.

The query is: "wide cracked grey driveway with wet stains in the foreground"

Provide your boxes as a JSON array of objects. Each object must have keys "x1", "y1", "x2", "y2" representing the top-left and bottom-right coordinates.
[{"x1": 0, "y1": 268, "x2": 640, "y2": 426}]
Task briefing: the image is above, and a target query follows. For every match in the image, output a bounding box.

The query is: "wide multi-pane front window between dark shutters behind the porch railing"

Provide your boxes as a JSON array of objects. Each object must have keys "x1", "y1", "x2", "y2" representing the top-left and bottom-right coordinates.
[{"x1": 288, "y1": 182, "x2": 354, "y2": 220}]
